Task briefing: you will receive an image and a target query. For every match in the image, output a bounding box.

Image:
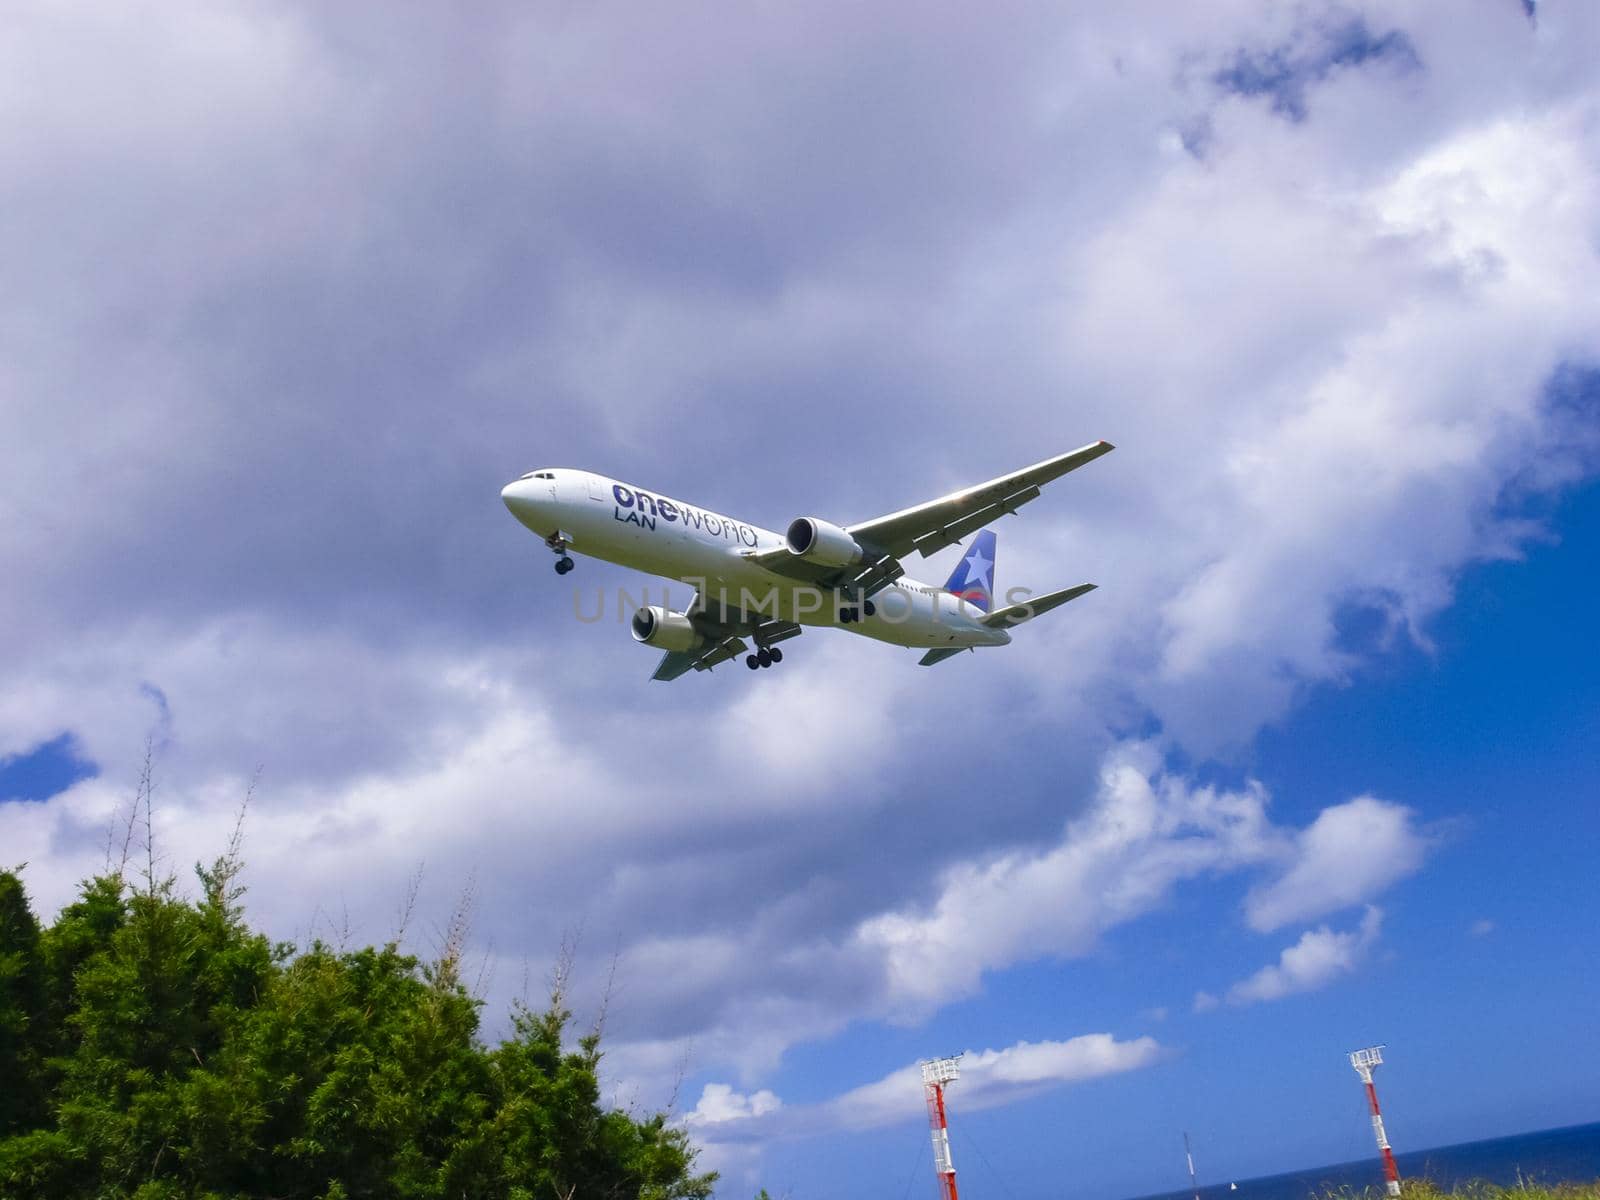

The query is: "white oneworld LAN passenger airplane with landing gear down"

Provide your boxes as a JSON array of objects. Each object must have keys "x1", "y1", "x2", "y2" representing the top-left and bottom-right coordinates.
[{"x1": 501, "y1": 442, "x2": 1115, "y2": 680}]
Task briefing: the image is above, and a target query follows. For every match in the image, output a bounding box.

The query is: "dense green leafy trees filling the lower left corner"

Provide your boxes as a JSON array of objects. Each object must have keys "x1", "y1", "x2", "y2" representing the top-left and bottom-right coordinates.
[{"x1": 0, "y1": 857, "x2": 715, "y2": 1200}]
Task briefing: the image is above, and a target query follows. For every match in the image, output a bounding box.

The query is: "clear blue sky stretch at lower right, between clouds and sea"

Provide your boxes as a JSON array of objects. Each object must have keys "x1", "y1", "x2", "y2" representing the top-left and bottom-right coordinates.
[{"x1": 742, "y1": 473, "x2": 1600, "y2": 1195}]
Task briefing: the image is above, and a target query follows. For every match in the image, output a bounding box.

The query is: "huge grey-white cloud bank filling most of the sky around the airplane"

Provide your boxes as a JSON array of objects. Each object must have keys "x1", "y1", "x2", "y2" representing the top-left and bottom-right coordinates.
[{"x1": 0, "y1": 3, "x2": 1600, "y2": 1164}]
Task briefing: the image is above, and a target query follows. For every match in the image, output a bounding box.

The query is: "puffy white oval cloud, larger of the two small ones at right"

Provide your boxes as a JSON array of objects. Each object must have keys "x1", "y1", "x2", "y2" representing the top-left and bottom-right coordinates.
[{"x1": 1245, "y1": 795, "x2": 1429, "y2": 933}]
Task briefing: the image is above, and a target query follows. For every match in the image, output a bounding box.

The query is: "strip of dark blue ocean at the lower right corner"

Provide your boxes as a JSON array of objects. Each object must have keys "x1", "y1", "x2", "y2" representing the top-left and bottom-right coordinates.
[{"x1": 1142, "y1": 1123, "x2": 1600, "y2": 1200}]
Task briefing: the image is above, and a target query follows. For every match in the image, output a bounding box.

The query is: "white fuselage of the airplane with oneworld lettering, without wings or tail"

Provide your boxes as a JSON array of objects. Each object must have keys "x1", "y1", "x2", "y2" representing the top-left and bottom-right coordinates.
[{"x1": 501, "y1": 469, "x2": 1011, "y2": 648}]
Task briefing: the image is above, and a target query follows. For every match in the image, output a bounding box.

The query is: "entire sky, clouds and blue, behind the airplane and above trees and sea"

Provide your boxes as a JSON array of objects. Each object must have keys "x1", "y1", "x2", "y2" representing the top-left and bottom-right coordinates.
[{"x1": 0, "y1": 0, "x2": 1600, "y2": 1197}]
